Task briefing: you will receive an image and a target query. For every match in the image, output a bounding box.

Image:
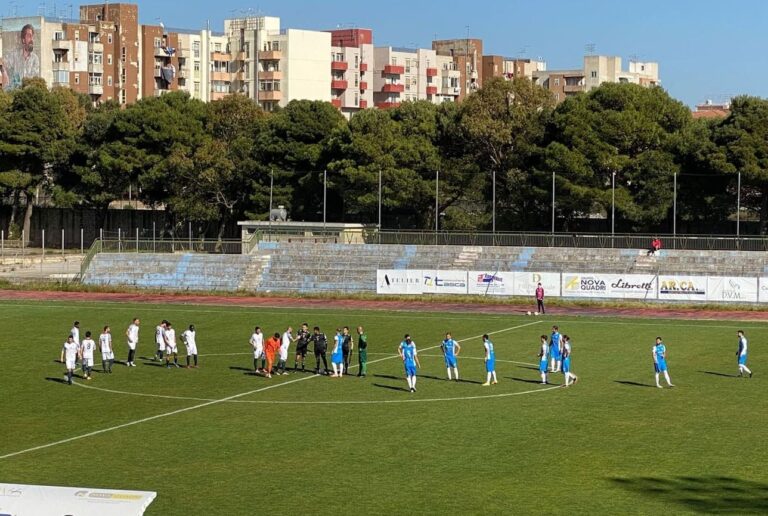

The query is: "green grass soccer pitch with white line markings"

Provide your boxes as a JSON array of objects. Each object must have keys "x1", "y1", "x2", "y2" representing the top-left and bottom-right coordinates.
[{"x1": 0, "y1": 302, "x2": 768, "y2": 516}]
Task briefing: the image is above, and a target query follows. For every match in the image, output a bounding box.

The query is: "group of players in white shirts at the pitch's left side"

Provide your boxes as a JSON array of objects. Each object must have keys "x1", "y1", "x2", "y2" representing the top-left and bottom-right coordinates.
[{"x1": 60, "y1": 318, "x2": 198, "y2": 385}]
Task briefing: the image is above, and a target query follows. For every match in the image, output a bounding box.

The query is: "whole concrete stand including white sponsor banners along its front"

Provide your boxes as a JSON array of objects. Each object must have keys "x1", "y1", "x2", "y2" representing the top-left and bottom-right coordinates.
[{"x1": 83, "y1": 242, "x2": 768, "y2": 303}]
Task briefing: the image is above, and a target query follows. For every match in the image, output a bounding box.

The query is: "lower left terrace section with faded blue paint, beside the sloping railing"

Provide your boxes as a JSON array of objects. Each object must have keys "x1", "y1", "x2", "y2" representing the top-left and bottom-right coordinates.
[{"x1": 83, "y1": 253, "x2": 253, "y2": 291}]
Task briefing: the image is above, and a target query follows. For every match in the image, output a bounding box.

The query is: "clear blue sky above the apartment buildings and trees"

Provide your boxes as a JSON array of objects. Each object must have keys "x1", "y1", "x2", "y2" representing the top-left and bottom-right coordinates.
[{"x1": 7, "y1": 0, "x2": 768, "y2": 105}]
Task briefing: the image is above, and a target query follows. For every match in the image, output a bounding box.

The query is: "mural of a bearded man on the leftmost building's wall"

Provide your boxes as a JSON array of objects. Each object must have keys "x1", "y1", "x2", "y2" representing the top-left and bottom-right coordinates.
[{"x1": 2, "y1": 18, "x2": 40, "y2": 90}]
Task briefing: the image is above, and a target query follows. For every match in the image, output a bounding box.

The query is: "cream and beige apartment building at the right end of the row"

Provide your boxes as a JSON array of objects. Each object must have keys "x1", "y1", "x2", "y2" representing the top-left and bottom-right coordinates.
[{"x1": 533, "y1": 56, "x2": 661, "y2": 102}]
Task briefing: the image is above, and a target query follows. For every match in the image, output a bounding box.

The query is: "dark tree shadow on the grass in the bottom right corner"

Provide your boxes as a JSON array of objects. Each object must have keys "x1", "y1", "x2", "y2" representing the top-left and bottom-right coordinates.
[{"x1": 611, "y1": 476, "x2": 768, "y2": 514}]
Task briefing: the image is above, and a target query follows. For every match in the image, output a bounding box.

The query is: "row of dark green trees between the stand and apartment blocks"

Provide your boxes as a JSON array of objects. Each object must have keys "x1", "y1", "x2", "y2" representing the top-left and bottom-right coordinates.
[{"x1": 0, "y1": 75, "x2": 768, "y2": 241}]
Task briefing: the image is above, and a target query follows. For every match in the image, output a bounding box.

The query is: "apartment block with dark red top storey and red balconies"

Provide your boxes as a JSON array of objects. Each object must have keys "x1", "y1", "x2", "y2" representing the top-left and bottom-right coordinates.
[{"x1": 328, "y1": 29, "x2": 374, "y2": 118}]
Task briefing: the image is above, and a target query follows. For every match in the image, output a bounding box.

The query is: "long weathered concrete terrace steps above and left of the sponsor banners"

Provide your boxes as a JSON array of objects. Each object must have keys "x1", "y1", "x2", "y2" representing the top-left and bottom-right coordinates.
[{"x1": 83, "y1": 246, "x2": 768, "y2": 293}]
